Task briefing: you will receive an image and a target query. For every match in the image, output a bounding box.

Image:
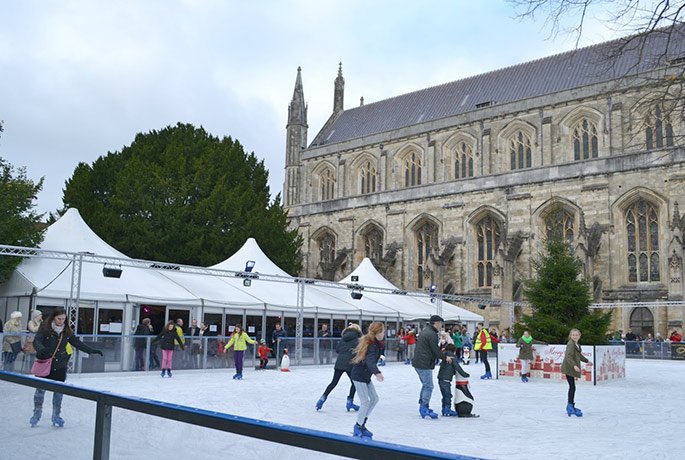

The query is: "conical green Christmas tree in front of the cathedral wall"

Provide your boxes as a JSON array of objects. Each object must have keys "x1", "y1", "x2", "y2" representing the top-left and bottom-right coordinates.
[{"x1": 515, "y1": 235, "x2": 611, "y2": 344}]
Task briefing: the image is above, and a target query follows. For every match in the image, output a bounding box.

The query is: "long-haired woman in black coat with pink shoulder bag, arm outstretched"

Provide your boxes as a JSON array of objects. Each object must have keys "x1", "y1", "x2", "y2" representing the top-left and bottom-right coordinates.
[{"x1": 29, "y1": 307, "x2": 102, "y2": 427}]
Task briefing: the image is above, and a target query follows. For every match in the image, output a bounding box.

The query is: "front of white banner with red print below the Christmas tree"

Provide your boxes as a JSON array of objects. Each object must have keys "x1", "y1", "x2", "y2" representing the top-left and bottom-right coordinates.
[{"x1": 497, "y1": 343, "x2": 592, "y2": 384}]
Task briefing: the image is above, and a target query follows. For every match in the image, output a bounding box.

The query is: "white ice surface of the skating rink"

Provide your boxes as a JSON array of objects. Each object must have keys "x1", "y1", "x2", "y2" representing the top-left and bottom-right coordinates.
[{"x1": 0, "y1": 360, "x2": 685, "y2": 460}]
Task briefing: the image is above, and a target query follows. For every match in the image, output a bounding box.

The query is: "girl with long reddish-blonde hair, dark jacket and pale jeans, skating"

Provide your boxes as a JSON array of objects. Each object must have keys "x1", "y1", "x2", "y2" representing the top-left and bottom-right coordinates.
[{"x1": 351, "y1": 322, "x2": 385, "y2": 439}]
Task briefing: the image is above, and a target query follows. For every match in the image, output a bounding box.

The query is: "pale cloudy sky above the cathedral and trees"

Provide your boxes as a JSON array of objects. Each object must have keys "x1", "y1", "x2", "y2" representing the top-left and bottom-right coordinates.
[{"x1": 0, "y1": 0, "x2": 616, "y2": 217}]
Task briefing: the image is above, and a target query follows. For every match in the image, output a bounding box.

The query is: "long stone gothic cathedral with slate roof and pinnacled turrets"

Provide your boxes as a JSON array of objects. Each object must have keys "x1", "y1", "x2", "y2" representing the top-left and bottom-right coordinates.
[{"x1": 283, "y1": 27, "x2": 685, "y2": 335}]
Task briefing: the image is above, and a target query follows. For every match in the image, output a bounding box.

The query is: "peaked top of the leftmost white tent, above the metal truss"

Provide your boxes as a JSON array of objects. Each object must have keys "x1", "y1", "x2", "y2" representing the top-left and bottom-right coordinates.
[{"x1": 40, "y1": 208, "x2": 128, "y2": 258}]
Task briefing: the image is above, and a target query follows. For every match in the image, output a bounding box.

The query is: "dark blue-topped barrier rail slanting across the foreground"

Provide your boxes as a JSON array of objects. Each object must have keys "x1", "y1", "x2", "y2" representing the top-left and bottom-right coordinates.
[{"x1": 0, "y1": 371, "x2": 483, "y2": 460}]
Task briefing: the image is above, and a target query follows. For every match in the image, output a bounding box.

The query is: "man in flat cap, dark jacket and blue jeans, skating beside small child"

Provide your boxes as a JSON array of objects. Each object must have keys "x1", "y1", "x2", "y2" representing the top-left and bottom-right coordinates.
[{"x1": 412, "y1": 315, "x2": 452, "y2": 418}]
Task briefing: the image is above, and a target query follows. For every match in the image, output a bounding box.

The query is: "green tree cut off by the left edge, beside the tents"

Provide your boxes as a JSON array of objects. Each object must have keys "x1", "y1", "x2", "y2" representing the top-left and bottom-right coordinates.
[{"x1": 0, "y1": 122, "x2": 44, "y2": 282}]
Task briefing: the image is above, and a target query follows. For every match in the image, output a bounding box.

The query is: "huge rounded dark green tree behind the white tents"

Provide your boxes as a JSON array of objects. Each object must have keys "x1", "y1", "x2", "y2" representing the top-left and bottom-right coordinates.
[{"x1": 63, "y1": 123, "x2": 302, "y2": 274}]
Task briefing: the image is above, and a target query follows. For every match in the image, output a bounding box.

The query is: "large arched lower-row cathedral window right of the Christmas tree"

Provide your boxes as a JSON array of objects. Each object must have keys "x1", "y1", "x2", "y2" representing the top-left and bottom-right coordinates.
[{"x1": 626, "y1": 200, "x2": 661, "y2": 283}]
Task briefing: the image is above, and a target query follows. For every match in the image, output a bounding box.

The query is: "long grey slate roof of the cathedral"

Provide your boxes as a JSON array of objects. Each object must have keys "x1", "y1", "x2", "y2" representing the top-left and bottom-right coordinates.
[{"x1": 310, "y1": 24, "x2": 685, "y2": 147}]
